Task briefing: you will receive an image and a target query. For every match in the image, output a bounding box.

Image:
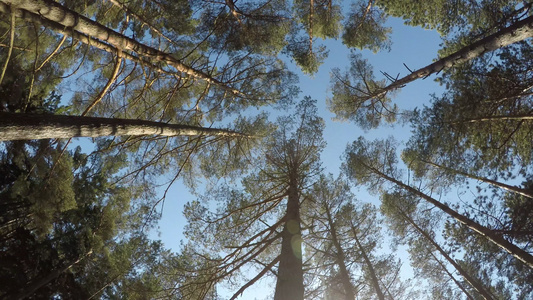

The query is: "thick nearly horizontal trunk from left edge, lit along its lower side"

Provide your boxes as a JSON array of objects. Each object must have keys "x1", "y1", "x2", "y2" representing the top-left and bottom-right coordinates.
[{"x1": 0, "y1": 112, "x2": 243, "y2": 141}]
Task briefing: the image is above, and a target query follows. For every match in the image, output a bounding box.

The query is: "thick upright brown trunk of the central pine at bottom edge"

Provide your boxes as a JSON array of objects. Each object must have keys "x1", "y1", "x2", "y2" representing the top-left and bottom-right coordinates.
[{"x1": 274, "y1": 175, "x2": 304, "y2": 300}]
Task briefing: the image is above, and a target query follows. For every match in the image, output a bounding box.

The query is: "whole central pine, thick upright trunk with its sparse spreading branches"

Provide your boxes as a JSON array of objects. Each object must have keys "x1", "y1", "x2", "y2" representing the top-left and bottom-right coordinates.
[{"x1": 186, "y1": 98, "x2": 324, "y2": 299}]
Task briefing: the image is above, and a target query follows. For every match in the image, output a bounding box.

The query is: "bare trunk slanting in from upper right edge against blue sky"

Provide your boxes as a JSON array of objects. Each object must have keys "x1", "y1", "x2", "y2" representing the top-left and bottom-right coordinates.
[{"x1": 366, "y1": 16, "x2": 533, "y2": 100}]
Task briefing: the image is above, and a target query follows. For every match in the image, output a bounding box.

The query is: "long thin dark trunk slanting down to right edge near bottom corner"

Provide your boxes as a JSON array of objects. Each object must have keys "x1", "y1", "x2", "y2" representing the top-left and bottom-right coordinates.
[{"x1": 363, "y1": 163, "x2": 533, "y2": 269}]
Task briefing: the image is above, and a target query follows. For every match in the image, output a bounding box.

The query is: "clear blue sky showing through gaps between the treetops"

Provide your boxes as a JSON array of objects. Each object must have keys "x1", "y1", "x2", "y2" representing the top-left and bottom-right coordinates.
[{"x1": 153, "y1": 18, "x2": 443, "y2": 299}]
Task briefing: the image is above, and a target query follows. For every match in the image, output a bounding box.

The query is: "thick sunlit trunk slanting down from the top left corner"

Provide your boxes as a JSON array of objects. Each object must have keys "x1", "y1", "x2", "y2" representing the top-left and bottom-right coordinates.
[{"x1": 0, "y1": 0, "x2": 243, "y2": 96}]
